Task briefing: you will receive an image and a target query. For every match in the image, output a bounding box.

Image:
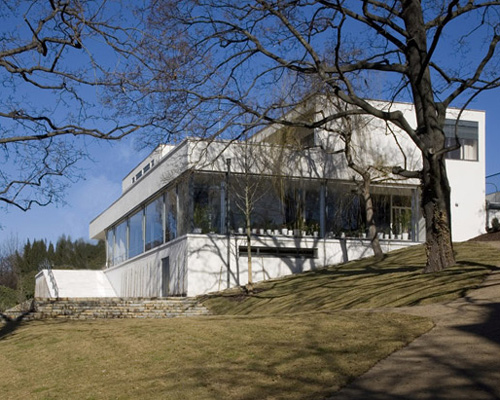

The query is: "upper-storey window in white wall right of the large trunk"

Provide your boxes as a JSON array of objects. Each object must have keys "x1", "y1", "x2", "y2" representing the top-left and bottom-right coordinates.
[{"x1": 444, "y1": 119, "x2": 479, "y2": 161}]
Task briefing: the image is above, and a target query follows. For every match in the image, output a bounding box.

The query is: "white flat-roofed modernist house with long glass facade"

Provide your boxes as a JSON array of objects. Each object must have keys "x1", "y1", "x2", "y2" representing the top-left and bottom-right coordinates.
[{"x1": 37, "y1": 103, "x2": 486, "y2": 297}]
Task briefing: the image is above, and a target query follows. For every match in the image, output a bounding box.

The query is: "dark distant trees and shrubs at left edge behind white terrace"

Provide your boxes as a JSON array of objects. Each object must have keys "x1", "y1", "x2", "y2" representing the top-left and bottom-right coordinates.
[{"x1": 0, "y1": 235, "x2": 106, "y2": 311}]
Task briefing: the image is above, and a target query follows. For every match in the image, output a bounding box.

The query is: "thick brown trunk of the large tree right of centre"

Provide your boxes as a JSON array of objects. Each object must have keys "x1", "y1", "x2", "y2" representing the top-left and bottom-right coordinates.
[{"x1": 401, "y1": 0, "x2": 455, "y2": 272}]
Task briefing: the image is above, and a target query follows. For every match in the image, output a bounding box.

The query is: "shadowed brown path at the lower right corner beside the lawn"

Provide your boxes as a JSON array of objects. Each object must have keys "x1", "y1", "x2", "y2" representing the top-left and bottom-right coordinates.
[{"x1": 331, "y1": 256, "x2": 500, "y2": 400}]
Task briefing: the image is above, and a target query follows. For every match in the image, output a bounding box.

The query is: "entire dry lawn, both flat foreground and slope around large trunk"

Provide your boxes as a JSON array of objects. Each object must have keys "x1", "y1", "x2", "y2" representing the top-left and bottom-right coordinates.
[{"x1": 0, "y1": 239, "x2": 500, "y2": 400}]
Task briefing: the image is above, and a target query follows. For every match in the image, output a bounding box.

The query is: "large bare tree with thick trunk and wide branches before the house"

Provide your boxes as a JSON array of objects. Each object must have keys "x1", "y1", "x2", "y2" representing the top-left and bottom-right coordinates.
[{"x1": 117, "y1": 0, "x2": 500, "y2": 272}]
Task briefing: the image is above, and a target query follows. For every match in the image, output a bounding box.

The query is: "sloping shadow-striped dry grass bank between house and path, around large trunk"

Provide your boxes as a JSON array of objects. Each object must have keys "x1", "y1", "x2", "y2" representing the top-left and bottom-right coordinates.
[{"x1": 204, "y1": 242, "x2": 500, "y2": 315}]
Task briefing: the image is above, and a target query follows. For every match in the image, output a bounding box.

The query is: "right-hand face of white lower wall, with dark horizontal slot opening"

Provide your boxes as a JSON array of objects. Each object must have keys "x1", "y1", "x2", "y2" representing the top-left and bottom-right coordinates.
[{"x1": 187, "y1": 234, "x2": 418, "y2": 296}]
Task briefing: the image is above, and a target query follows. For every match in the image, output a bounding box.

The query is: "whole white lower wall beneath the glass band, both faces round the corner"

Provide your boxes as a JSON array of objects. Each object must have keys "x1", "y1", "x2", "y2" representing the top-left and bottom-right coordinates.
[{"x1": 98, "y1": 234, "x2": 417, "y2": 297}]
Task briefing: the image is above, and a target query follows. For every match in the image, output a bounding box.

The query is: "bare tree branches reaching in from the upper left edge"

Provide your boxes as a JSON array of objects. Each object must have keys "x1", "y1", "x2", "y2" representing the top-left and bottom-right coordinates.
[{"x1": 0, "y1": 0, "x2": 149, "y2": 211}]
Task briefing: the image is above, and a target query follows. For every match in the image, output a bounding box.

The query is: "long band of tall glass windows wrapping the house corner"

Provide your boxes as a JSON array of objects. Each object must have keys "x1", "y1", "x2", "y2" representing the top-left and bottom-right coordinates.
[{"x1": 106, "y1": 174, "x2": 416, "y2": 266}]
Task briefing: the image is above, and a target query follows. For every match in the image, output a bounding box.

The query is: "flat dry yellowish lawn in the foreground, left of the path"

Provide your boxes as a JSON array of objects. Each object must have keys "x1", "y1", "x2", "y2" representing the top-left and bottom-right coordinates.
[{"x1": 0, "y1": 312, "x2": 432, "y2": 400}]
